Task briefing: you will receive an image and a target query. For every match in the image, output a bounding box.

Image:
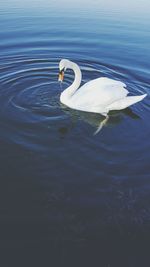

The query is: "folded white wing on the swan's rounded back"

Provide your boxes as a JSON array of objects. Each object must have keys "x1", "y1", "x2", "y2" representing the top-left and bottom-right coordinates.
[{"x1": 72, "y1": 78, "x2": 128, "y2": 112}]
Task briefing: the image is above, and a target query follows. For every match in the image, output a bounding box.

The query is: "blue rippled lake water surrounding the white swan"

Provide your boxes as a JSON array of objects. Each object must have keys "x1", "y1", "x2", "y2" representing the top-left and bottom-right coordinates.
[{"x1": 0, "y1": 1, "x2": 150, "y2": 267}]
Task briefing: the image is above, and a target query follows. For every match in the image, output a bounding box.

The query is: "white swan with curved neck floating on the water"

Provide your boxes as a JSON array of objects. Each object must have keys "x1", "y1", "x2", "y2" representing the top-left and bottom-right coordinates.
[{"x1": 59, "y1": 59, "x2": 146, "y2": 116}]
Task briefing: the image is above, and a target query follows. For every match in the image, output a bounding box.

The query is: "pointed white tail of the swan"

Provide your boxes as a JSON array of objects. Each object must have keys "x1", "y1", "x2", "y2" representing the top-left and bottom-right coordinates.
[{"x1": 108, "y1": 94, "x2": 147, "y2": 110}]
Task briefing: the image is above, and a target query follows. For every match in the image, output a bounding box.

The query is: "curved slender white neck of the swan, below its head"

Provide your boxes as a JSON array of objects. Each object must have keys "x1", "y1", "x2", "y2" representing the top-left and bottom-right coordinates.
[{"x1": 60, "y1": 62, "x2": 82, "y2": 104}]
